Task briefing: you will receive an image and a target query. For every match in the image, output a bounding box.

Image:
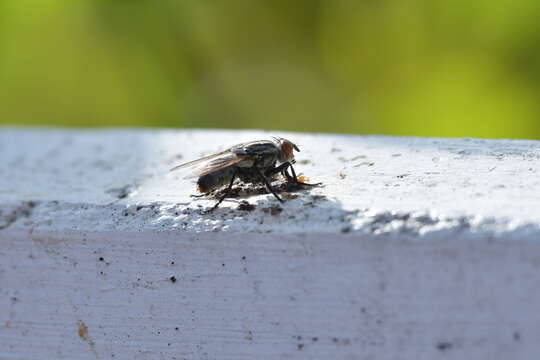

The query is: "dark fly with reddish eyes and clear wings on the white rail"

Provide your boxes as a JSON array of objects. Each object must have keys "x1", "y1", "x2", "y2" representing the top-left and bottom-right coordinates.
[{"x1": 171, "y1": 138, "x2": 320, "y2": 210}]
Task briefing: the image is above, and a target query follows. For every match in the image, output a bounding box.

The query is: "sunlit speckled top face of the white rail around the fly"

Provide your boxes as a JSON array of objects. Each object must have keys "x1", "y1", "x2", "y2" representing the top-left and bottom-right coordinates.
[{"x1": 0, "y1": 129, "x2": 540, "y2": 238}]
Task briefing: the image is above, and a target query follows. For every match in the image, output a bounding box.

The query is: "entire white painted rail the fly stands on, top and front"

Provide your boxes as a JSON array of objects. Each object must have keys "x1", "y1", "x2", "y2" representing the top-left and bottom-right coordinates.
[{"x1": 0, "y1": 129, "x2": 540, "y2": 359}]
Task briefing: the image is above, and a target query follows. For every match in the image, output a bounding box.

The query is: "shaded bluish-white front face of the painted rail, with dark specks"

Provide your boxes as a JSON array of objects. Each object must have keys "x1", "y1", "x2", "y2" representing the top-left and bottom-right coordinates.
[{"x1": 0, "y1": 231, "x2": 540, "y2": 360}]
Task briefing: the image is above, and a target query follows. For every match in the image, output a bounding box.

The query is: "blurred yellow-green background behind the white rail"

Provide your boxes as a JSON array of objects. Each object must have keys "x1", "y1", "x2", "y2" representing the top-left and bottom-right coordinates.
[{"x1": 0, "y1": 0, "x2": 540, "y2": 139}]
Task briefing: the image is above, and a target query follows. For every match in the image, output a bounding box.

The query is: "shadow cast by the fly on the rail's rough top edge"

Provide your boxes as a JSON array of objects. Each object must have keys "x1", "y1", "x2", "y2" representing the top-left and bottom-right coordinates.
[{"x1": 180, "y1": 186, "x2": 357, "y2": 233}]
